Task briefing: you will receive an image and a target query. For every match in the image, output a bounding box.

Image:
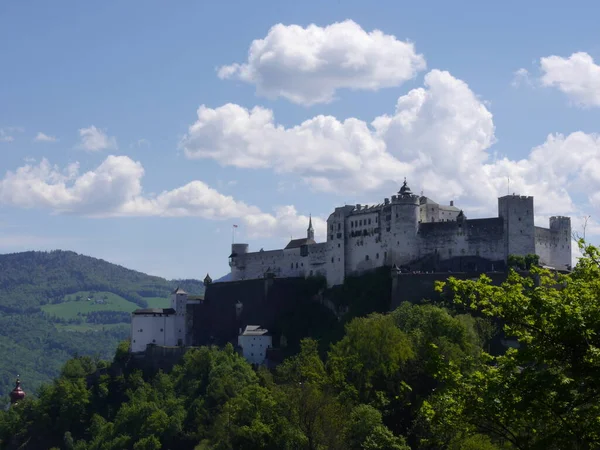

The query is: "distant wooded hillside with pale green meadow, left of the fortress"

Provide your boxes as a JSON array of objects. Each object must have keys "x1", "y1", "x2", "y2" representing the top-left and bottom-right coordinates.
[{"x1": 0, "y1": 250, "x2": 204, "y2": 396}]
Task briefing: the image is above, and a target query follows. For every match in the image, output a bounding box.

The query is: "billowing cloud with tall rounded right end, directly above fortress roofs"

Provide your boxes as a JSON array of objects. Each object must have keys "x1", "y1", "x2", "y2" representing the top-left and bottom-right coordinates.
[{"x1": 181, "y1": 70, "x2": 494, "y2": 199}]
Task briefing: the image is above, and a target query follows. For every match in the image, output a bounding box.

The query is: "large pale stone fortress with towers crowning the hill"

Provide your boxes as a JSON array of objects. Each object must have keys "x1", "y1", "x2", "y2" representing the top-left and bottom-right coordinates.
[{"x1": 229, "y1": 180, "x2": 571, "y2": 286}]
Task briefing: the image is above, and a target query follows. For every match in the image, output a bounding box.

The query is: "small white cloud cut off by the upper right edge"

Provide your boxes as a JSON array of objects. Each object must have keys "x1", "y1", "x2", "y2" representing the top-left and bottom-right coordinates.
[{"x1": 540, "y1": 52, "x2": 600, "y2": 107}]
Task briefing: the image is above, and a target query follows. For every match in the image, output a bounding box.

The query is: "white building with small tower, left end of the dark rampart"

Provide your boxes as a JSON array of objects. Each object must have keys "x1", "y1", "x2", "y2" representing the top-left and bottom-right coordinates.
[{"x1": 130, "y1": 289, "x2": 187, "y2": 353}]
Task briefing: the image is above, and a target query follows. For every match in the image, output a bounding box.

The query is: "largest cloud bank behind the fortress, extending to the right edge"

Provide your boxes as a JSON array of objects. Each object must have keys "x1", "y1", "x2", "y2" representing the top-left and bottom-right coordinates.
[{"x1": 181, "y1": 70, "x2": 600, "y2": 224}]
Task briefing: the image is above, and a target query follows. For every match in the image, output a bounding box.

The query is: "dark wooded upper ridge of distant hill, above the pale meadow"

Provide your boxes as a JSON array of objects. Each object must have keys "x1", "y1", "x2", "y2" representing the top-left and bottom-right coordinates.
[{"x1": 0, "y1": 250, "x2": 204, "y2": 313}]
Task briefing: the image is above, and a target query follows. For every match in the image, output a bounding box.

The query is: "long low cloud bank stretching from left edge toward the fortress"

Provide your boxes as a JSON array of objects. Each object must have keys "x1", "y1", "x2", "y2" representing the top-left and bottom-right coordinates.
[{"x1": 0, "y1": 155, "x2": 325, "y2": 237}]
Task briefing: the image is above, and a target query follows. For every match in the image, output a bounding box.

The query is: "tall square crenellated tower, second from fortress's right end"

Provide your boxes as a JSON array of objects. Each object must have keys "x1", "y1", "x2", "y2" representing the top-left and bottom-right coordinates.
[{"x1": 498, "y1": 194, "x2": 536, "y2": 261}]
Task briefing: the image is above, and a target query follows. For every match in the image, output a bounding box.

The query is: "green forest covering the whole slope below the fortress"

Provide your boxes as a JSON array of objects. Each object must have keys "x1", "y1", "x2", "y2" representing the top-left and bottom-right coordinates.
[{"x1": 0, "y1": 242, "x2": 600, "y2": 450}]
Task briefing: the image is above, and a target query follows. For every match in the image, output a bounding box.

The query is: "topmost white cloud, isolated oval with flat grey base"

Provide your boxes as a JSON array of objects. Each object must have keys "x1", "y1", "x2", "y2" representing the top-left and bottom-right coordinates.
[{"x1": 218, "y1": 20, "x2": 426, "y2": 106}]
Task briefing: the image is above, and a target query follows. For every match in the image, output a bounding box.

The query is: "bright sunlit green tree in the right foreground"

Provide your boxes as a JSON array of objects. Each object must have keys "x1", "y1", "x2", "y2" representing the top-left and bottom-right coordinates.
[{"x1": 422, "y1": 242, "x2": 600, "y2": 449}]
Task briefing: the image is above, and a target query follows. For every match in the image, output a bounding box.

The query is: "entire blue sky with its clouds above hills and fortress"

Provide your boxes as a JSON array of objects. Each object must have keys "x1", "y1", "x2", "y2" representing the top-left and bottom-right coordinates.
[{"x1": 0, "y1": 0, "x2": 600, "y2": 278}]
